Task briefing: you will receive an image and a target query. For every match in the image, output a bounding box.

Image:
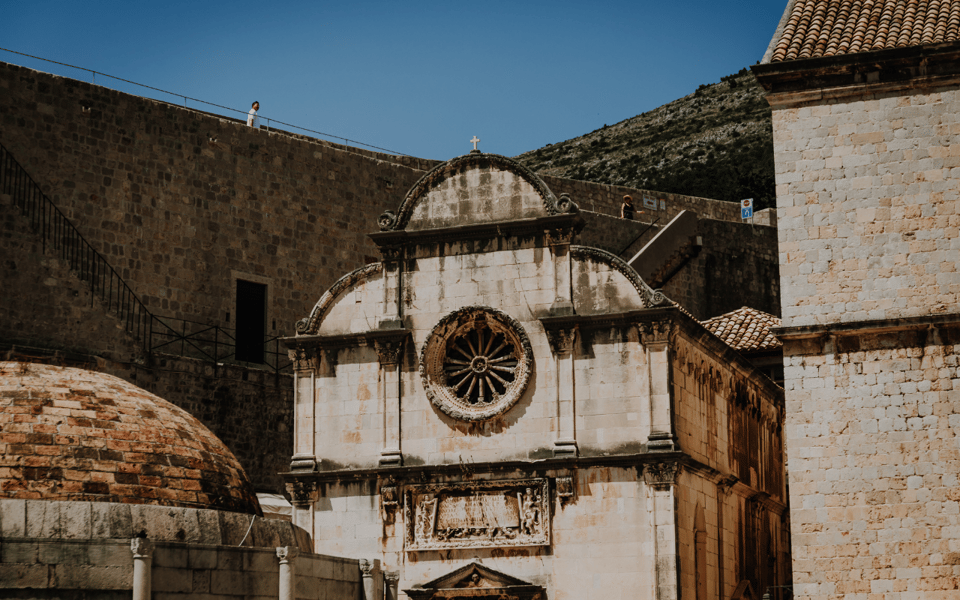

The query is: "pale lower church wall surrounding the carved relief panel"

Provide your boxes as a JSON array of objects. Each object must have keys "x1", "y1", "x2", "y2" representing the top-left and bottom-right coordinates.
[{"x1": 314, "y1": 466, "x2": 657, "y2": 600}]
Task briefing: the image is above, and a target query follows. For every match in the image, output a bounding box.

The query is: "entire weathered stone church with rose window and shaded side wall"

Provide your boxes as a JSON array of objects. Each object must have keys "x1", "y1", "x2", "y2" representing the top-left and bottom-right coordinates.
[{"x1": 285, "y1": 152, "x2": 790, "y2": 600}]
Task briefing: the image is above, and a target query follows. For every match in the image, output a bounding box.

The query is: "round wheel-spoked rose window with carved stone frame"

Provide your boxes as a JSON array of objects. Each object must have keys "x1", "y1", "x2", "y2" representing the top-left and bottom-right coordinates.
[{"x1": 420, "y1": 306, "x2": 532, "y2": 421}]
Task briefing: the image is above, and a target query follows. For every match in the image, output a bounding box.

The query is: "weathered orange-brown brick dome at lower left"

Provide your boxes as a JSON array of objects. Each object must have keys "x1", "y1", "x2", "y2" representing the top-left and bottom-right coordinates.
[{"x1": 0, "y1": 362, "x2": 260, "y2": 514}]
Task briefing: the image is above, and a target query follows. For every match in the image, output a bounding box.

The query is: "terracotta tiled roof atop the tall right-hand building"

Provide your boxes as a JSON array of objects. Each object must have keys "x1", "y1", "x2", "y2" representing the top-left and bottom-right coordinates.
[{"x1": 770, "y1": 0, "x2": 960, "y2": 62}]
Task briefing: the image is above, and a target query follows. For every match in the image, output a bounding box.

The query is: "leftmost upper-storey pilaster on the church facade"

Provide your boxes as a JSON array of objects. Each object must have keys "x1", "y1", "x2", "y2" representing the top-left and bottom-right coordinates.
[{"x1": 289, "y1": 347, "x2": 322, "y2": 473}]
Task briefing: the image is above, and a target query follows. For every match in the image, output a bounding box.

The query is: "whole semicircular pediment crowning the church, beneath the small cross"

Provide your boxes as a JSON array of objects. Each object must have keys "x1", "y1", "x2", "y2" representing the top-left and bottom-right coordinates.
[{"x1": 378, "y1": 152, "x2": 576, "y2": 231}]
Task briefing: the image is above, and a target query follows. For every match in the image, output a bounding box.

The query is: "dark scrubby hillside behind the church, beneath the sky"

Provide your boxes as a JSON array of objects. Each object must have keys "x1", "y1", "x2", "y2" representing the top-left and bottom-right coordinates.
[{"x1": 517, "y1": 69, "x2": 776, "y2": 210}]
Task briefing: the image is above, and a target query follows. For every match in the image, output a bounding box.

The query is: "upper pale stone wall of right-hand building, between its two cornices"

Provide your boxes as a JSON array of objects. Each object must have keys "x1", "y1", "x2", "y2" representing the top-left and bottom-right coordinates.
[{"x1": 773, "y1": 86, "x2": 960, "y2": 326}]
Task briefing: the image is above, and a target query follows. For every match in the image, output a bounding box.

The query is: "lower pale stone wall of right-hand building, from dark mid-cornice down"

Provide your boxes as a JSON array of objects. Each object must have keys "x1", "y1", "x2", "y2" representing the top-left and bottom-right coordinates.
[{"x1": 784, "y1": 325, "x2": 960, "y2": 600}]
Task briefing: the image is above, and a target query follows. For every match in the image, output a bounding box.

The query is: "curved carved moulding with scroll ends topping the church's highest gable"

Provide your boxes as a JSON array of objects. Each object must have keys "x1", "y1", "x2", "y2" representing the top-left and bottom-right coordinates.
[{"x1": 377, "y1": 152, "x2": 577, "y2": 231}]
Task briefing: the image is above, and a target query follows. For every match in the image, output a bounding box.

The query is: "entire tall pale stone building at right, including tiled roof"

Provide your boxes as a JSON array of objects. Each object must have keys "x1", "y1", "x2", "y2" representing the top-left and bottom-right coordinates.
[{"x1": 754, "y1": 0, "x2": 960, "y2": 600}]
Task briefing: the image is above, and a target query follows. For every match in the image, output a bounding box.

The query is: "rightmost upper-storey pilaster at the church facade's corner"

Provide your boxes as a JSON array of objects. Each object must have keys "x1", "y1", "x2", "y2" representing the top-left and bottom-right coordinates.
[{"x1": 637, "y1": 321, "x2": 679, "y2": 452}]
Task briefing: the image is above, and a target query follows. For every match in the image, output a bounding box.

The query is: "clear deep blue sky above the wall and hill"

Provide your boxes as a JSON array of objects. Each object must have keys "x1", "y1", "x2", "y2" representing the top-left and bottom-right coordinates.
[{"x1": 0, "y1": 0, "x2": 787, "y2": 160}]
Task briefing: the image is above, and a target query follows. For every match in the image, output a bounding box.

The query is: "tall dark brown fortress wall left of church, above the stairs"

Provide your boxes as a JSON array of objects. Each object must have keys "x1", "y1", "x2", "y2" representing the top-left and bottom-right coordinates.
[{"x1": 0, "y1": 64, "x2": 426, "y2": 333}]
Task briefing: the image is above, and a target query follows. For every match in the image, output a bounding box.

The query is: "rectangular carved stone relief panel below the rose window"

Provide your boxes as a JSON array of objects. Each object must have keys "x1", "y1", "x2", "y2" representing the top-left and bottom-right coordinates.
[{"x1": 404, "y1": 479, "x2": 550, "y2": 551}]
